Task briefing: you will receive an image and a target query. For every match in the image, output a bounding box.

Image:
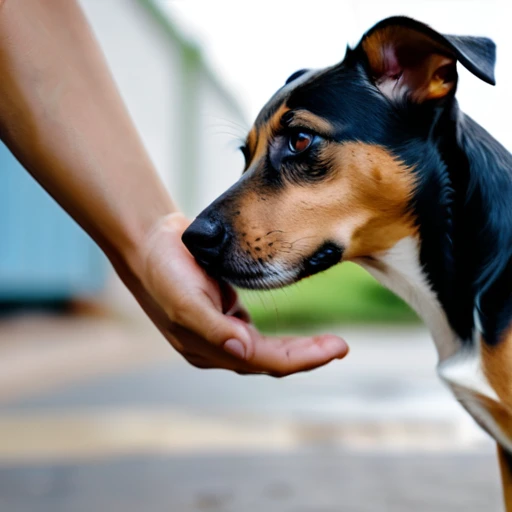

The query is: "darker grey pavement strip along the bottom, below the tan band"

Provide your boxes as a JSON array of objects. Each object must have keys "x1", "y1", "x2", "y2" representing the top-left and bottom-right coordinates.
[{"x1": 0, "y1": 452, "x2": 500, "y2": 512}]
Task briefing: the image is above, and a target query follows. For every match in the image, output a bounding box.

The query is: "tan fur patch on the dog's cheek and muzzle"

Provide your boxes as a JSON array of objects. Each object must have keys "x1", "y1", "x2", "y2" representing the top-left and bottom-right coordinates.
[{"x1": 230, "y1": 142, "x2": 416, "y2": 268}]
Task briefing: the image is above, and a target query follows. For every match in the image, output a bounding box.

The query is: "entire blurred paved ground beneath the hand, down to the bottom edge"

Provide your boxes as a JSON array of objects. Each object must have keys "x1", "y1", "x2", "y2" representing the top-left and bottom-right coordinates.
[{"x1": 0, "y1": 317, "x2": 501, "y2": 512}]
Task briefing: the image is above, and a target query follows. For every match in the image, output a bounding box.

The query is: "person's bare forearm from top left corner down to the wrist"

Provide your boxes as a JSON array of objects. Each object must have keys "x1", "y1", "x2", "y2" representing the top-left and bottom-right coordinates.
[{"x1": 0, "y1": 0, "x2": 175, "y2": 268}]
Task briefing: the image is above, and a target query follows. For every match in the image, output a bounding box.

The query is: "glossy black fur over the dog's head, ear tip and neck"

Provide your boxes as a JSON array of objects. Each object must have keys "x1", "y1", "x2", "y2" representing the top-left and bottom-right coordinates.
[{"x1": 260, "y1": 17, "x2": 512, "y2": 344}]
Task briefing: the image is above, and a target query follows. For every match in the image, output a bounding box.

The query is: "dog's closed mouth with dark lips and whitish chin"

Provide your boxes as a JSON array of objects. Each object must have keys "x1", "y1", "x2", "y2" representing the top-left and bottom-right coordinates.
[{"x1": 205, "y1": 242, "x2": 343, "y2": 290}]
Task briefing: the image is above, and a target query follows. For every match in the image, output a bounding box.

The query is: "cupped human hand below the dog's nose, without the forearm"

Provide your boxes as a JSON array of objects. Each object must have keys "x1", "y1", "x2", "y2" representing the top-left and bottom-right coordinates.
[{"x1": 131, "y1": 213, "x2": 348, "y2": 377}]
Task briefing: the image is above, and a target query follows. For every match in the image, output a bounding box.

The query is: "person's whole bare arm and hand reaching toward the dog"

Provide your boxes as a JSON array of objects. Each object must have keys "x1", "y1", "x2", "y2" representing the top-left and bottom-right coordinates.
[{"x1": 0, "y1": 0, "x2": 348, "y2": 376}]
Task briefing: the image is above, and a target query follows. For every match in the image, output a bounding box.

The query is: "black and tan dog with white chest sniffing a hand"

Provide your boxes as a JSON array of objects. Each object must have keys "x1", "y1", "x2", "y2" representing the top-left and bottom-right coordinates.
[{"x1": 183, "y1": 17, "x2": 512, "y2": 512}]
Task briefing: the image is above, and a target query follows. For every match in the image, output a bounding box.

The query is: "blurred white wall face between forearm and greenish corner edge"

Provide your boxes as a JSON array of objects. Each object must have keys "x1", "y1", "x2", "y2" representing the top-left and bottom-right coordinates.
[{"x1": 80, "y1": 0, "x2": 180, "y2": 191}]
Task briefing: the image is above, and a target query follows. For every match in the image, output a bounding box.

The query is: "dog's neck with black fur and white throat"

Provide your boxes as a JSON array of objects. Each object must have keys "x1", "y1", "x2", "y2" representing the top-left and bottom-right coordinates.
[{"x1": 360, "y1": 103, "x2": 512, "y2": 360}]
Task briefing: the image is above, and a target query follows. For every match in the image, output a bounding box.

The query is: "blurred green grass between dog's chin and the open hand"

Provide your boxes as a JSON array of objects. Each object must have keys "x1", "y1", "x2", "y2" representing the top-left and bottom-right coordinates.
[{"x1": 241, "y1": 263, "x2": 418, "y2": 332}]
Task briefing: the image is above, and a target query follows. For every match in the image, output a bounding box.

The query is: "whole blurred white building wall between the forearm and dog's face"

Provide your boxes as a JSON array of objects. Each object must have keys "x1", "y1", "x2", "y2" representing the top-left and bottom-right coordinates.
[{"x1": 81, "y1": 0, "x2": 247, "y2": 215}]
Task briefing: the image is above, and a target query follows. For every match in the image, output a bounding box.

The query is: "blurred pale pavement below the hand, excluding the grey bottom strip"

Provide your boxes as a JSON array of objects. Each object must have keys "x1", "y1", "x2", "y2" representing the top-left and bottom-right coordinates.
[{"x1": 0, "y1": 319, "x2": 492, "y2": 460}]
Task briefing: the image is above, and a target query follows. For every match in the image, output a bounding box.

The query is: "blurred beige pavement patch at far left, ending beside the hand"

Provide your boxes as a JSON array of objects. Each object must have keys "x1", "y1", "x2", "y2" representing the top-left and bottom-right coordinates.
[{"x1": 0, "y1": 313, "x2": 180, "y2": 404}]
